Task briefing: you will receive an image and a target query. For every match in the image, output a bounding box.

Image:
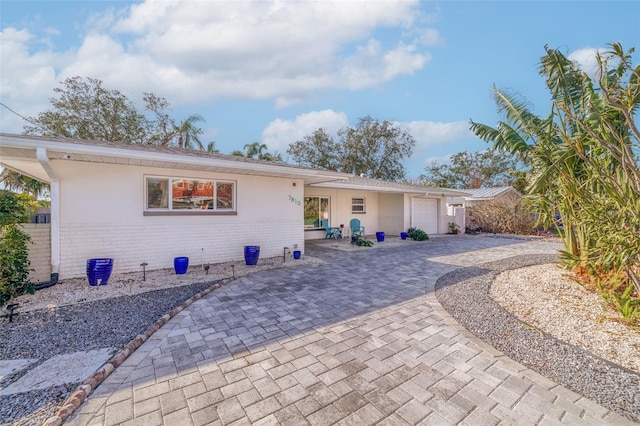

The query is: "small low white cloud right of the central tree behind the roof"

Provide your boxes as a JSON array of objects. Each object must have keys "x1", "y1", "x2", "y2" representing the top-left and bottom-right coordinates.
[{"x1": 397, "y1": 121, "x2": 473, "y2": 152}]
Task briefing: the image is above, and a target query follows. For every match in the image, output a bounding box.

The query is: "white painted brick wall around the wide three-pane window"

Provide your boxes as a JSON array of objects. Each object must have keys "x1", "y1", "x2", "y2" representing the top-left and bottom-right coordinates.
[{"x1": 53, "y1": 161, "x2": 304, "y2": 278}]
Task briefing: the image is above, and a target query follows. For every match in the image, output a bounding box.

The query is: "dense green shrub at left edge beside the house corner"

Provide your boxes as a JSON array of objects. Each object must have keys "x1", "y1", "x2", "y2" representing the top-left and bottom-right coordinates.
[{"x1": 0, "y1": 191, "x2": 34, "y2": 305}]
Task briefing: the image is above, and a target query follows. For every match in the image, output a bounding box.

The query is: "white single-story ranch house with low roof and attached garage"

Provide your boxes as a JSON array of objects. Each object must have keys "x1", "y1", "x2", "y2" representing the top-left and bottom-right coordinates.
[{"x1": 0, "y1": 133, "x2": 465, "y2": 278}]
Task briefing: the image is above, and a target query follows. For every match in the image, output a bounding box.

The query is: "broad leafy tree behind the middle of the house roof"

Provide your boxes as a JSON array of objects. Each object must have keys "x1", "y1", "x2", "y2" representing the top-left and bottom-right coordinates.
[{"x1": 287, "y1": 116, "x2": 416, "y2": 181}]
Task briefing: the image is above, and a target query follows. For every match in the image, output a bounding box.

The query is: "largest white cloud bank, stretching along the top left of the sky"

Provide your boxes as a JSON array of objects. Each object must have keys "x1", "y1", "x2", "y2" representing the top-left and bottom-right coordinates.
[{"x1": 0, "y1": 0, "x2": 439, "y2": 130}]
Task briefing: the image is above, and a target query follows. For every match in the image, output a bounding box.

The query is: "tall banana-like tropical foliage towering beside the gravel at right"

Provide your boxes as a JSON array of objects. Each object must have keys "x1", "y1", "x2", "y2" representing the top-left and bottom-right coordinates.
[{"x1": 472, "y1": 43, "x2": 640, "y2": 293}]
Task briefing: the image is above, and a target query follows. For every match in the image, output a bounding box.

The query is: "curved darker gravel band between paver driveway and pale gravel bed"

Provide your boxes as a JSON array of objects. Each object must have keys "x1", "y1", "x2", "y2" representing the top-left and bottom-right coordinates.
[{"x1": 436, "y1": 255, "x2": 640, "y2": 421}]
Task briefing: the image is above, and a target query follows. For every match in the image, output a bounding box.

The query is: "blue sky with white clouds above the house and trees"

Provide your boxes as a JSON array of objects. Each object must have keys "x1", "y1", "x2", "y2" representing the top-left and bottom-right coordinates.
[{"x1": 0, "y1": 0, "x2": 640, "y2": 178}]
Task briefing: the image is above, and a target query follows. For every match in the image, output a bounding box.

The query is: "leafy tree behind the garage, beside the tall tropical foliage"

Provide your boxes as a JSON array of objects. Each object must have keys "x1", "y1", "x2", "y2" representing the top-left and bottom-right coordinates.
[{"x1": 419, "y1": 150, "x2": 522, "y2": 189}]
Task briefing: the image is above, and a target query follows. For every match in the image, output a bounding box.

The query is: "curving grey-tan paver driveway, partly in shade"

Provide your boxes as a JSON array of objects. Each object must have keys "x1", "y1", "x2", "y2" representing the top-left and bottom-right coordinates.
[{"x1": 69, "y1": 236, "x2": 630, "y2": 425}]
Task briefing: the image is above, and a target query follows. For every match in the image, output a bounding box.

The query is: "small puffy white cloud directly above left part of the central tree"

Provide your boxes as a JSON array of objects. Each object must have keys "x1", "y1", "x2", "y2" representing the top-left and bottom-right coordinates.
[{"x1": 262, "y1": 109, "x2": 349, "y2": 154}]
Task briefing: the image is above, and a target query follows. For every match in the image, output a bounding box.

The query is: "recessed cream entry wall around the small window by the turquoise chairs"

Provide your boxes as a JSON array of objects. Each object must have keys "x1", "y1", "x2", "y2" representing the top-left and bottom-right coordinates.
[{"x1": 304, "y1": 187, "x2": 379, "y2": 240}]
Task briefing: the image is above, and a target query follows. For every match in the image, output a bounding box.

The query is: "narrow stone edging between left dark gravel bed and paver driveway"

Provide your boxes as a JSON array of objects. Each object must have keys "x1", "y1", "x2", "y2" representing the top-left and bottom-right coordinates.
[{"x1": 42, "y1": 278, "x2": 232, "y2": 426}]
